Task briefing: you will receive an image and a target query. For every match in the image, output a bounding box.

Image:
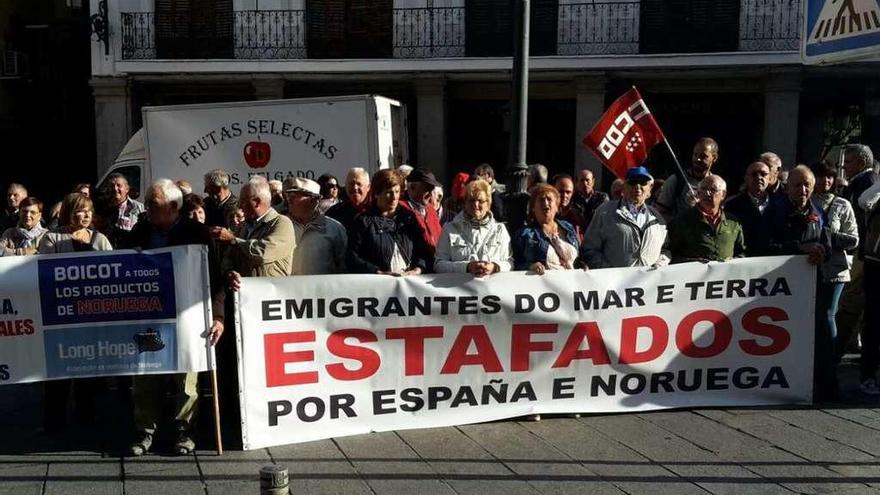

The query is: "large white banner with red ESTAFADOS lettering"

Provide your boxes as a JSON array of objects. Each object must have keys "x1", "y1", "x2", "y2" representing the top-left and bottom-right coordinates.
[{"x1": 238, "y1": 256, "x2": 816, "y2": 449}]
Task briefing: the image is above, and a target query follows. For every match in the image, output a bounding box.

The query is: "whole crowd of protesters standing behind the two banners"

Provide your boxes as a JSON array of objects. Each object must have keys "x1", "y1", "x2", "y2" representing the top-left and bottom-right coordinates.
[{"x1": 0, "y1": 138, "x2": 880, "y2": 455}]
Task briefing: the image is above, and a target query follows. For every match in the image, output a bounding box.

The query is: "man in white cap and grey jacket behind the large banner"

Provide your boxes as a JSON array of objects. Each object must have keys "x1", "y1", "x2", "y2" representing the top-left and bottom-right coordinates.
[{"x1": 283, "y1": 177, "x2": 348, "y2": 275}]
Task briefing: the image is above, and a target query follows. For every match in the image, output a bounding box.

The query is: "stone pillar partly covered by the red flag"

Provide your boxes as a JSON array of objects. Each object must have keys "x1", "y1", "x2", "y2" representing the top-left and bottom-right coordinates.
[{"x1": 571, "y1": 75, "x2": 608, "y2": 186}]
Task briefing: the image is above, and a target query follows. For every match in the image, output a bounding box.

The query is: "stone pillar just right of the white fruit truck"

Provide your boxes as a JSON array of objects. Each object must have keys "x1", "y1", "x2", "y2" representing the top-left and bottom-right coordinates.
[{"x1": 411, "y1": 77, "x2": 452, "y2": 184}]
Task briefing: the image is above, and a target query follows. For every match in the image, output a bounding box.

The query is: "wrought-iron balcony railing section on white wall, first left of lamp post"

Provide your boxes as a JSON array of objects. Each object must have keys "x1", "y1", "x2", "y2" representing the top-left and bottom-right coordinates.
[{"x1": 394, "y1": 7, "x2": 464, "y2": 58}]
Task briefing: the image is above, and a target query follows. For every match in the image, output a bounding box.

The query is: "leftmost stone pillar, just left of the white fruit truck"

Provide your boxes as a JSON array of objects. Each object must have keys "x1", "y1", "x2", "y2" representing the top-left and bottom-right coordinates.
[{"x1": 89, "y1": 77, "x2": 134, "y2": 180}]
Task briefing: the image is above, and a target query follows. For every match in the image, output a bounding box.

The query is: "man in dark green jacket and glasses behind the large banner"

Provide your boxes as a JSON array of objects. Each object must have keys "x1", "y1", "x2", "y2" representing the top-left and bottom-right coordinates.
[{"x1": 669, "y1": 175, "x2": 745, "y2": 263}]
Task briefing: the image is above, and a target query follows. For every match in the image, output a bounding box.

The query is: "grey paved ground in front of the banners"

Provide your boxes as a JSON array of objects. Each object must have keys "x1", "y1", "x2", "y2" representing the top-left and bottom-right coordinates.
[{"x1": 0, "y1": 364, "x2": 880, "y2": 495}]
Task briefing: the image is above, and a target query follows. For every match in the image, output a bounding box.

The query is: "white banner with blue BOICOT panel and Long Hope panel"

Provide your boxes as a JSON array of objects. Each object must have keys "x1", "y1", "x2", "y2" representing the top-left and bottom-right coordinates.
[{"x1": 0, "y1": 246, "x2": 210, "y2": 384}]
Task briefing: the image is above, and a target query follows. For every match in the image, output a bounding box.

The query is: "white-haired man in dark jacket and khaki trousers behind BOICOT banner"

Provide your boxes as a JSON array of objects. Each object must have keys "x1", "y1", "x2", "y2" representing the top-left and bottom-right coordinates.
[{"x1": 121, "y1": 179, "x2": 223, "y2": 456}]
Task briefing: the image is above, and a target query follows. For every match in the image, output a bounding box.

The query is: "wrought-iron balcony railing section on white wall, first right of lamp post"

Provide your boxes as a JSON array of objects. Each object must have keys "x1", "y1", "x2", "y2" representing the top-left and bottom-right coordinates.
[{"x1": 556, "y1": 1, "x2": 639, "y2": 55}]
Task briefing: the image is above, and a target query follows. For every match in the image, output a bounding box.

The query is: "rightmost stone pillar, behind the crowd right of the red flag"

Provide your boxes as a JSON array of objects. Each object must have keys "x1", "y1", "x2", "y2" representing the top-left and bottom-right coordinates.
[{"x1": 761, "y1": 69, "x2": 801, "y2": 169}]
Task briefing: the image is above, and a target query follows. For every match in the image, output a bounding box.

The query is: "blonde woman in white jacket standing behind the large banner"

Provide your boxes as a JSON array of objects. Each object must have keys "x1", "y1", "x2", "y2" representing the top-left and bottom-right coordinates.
[{"x1": 434, "y1": 179, "x2": 513, "y2": 277}]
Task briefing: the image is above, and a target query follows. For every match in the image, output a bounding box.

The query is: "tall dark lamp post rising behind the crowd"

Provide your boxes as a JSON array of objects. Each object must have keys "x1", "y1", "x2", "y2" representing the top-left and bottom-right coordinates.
[{"x1": 507, "y1": 0, "x2": 529, "y2": 194}]
